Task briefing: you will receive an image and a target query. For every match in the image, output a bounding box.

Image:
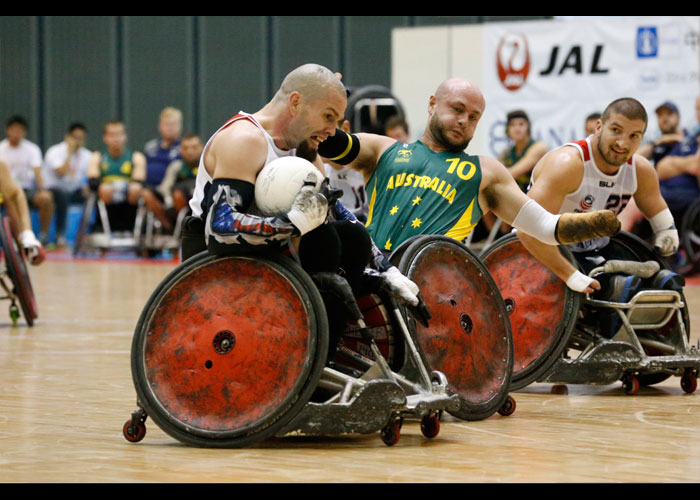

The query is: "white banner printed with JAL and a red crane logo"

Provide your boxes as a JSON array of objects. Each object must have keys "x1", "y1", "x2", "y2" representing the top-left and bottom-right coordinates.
[{"x1": 479, "y1": 17, "x2": 700, "y2": 155}]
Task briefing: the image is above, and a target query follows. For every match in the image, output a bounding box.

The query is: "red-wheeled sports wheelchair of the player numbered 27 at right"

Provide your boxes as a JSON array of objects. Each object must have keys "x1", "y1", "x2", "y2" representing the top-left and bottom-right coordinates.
[{"x1": 481, "y1": 232, "x2": 700, "y2": 394}]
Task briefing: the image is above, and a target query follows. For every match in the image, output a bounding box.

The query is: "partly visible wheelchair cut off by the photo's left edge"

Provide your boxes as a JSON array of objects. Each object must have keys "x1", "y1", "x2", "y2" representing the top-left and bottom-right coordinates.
[{"x1": 0, "y1": 215, "x2": 38, "y2": 326}]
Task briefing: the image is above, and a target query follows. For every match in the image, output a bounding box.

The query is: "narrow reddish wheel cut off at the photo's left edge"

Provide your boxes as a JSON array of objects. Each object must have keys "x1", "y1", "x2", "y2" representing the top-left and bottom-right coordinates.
[{"x1": 0, "y1": 216, "x2": 38, "y2": 326}]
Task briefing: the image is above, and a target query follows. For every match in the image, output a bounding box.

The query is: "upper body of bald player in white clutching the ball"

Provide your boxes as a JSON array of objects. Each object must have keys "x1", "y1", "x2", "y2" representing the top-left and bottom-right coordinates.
[{"x1": 182, "y1": 64, "x2": 347, "y2": 260}]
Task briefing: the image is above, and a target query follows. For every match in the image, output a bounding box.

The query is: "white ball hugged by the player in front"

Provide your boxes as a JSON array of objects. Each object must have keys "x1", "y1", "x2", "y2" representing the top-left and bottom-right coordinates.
[{"x1": 255, "y1": 156, "x2": 323, "y2": 216}]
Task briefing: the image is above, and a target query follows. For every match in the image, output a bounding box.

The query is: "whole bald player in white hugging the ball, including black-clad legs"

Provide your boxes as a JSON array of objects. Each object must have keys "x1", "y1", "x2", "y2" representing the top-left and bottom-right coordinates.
[{"x1": 182, "y1": 64, "x2": 419, "y2": 360}]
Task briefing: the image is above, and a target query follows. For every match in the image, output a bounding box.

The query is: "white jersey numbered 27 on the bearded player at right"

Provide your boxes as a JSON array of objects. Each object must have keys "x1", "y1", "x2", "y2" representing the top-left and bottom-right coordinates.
[{"x1": 559, "y1": 137, "x2": 637, "y2": 252}]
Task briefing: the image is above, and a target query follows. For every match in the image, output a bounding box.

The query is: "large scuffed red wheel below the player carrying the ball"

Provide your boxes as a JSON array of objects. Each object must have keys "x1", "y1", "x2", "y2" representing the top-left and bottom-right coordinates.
[{"x1": 131, "y1": 252, "x2": 328, "y2": 447}]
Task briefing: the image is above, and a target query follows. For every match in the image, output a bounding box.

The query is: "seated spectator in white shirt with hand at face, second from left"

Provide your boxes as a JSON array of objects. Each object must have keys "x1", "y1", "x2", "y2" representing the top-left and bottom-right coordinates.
[{"x1": 44, "y1": 123, "x2": 92, "y2": 248}]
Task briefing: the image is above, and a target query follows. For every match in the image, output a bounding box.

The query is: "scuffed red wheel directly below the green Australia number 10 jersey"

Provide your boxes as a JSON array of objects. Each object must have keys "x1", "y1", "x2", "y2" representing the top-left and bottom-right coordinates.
[{"x1": 398, "y1": 236, "x2": 513, "y2": 420}]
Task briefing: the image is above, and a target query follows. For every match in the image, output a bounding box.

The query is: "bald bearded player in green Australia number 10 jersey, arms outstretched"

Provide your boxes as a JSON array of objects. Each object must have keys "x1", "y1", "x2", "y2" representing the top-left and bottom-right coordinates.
[{"x1": 318, "y1": 78, "x2": 619, "y2": 274}]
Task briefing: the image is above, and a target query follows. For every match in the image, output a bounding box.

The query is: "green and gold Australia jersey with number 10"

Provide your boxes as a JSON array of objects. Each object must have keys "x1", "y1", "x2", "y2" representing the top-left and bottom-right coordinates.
[{"x1": 365, "y1": 141, "x2": 482, "y2": 251}]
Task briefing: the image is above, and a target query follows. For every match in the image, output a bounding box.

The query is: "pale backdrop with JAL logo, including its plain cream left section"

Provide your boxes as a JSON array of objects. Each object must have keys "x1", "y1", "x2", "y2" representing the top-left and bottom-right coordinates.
[{"x1": 392, "y1": 16, "x2": 700, "y2": 156}]
